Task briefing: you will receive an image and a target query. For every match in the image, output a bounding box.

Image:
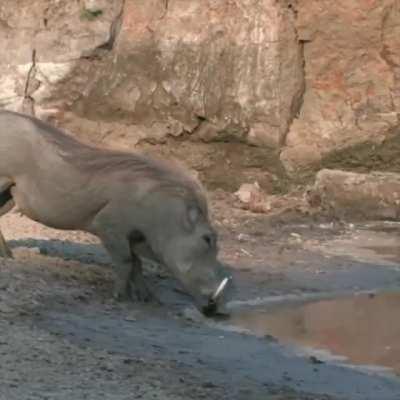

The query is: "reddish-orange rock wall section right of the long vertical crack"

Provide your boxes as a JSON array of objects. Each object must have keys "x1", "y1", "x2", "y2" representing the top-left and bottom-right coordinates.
[{"x1": 281, "y1": 0, "x2": 400, "y2": 172}]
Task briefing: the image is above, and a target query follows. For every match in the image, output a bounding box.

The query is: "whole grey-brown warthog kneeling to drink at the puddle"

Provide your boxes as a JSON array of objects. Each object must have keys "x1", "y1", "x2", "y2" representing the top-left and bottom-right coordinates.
[{"x1": 0, "y1": 111, "x2": 231, "y2": 315}]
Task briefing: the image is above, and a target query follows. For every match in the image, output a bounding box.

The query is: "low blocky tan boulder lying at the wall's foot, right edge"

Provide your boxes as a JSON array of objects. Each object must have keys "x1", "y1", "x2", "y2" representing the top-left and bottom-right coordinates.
[{"x1": 309, "y1": 169, "x2": 400, "y2": 220}]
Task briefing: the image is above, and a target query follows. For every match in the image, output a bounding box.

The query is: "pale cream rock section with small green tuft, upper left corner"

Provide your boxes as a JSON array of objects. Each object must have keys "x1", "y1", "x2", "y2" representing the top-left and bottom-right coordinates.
[{"x1": 0, "y1": 0, "x2": 122, "y2": 116}]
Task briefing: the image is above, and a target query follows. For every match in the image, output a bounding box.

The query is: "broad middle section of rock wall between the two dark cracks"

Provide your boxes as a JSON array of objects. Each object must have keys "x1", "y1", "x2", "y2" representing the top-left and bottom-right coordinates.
[{"x1": 64, "y1": 0, "x2": 303, "y2": 148}]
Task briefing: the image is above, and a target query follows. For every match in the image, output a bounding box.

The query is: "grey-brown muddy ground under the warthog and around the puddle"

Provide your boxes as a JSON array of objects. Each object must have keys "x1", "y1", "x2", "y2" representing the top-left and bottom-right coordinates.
[{"x1": 0, "y1": 193, "x2": 400, "y2": 400}]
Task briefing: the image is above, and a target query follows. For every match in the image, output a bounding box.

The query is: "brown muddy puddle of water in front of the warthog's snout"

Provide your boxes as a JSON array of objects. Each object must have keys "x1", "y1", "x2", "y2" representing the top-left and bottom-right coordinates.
[{"x1": 230, "y1": 293, "x2": 400, "y2": 374}]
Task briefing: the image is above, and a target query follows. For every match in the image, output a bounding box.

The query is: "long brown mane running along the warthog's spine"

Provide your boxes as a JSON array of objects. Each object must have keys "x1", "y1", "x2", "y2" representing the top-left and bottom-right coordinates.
[{"x1": 14, "y1": 109, "x2": 208, "y2": 215}]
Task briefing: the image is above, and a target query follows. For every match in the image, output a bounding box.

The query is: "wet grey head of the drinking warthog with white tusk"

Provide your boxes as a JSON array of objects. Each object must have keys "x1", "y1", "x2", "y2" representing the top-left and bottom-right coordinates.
[{"x1": 143, "y1": 189, "x2": 232, "y2": 316}]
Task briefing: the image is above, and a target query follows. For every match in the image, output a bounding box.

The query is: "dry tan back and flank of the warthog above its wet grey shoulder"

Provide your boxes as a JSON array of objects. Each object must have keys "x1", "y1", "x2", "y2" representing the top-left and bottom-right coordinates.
[{"x1": 0, "y1": 111, "x2": 207, "y2": 229}]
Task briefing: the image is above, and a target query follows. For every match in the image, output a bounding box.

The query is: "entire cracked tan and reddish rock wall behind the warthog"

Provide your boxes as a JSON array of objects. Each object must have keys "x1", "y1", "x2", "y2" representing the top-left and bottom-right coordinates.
[{"x1": 0, "y1": 0, "x2": 400, "y2": 175}]
